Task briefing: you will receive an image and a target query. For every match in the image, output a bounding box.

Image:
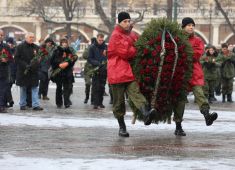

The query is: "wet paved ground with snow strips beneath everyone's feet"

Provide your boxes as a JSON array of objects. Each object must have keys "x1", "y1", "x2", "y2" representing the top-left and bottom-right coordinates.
[{"x1": 0, "y1": 79, "x2": 235, "y2": 170}]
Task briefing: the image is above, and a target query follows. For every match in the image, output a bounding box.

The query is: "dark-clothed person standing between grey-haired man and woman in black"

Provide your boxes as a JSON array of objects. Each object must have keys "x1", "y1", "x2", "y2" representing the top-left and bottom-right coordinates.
[{"x1": 38, "y1": 38, "x2": 56, "y2": 100}]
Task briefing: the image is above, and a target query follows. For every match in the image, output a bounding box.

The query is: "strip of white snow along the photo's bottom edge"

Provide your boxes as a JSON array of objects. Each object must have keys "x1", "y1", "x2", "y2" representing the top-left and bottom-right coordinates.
[{"x1": 0, "y1": 155, "x2": 235, "y2": 170}]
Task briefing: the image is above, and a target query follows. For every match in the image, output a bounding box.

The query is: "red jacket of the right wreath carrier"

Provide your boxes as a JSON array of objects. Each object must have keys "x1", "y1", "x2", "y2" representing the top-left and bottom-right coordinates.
[{"x1": 189, "y1": 35, "x2": 204, "y2": 87}]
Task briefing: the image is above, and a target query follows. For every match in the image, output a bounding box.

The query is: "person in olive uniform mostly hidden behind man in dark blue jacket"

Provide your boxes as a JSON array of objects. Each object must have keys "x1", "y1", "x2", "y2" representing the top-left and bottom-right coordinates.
[{"x1": 82, "y1": 37, "x2": 96, "y2": 104}]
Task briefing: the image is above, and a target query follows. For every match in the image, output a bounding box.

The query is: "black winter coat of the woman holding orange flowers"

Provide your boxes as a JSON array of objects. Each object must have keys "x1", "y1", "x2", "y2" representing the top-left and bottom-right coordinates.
[{"x1": 50, "y1": 46, "x2": 78, "y2": 82}]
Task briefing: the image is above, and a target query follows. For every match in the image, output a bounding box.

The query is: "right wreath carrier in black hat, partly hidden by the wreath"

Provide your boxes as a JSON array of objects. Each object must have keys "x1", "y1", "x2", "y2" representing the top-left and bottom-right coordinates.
[{"x1": 174, "y1": 17, "x2": 218, "y2": 136}]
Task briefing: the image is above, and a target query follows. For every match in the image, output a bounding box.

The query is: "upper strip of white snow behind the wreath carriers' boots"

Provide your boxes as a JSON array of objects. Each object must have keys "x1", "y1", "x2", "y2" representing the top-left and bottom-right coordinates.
[{"x1": 0, "y1": 110, "x2": 235, "y2": 133}]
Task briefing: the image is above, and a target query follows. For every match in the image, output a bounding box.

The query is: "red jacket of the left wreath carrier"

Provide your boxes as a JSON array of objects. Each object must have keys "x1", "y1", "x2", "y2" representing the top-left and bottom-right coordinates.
[{"x1": 107, "y1": 25, "x2": 138, "y2": 84}]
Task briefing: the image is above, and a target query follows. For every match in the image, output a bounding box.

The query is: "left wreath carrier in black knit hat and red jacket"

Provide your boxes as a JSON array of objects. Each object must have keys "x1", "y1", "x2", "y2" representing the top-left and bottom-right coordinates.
[{"x1": 107, "y1": 12, "x2": 156, "y2": 137}]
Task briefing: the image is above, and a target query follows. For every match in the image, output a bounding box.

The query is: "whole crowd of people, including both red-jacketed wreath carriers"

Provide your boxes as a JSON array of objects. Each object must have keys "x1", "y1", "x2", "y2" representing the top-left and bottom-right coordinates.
[{"x1": 0, "y1": 12, "x2": 235, "y2": 137}]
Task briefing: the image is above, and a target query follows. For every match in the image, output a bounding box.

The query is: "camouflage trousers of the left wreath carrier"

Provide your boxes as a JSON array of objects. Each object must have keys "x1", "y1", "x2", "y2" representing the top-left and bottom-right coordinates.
[{"x1": 111, "y1": 81, "x2": 147, "y2": 118}]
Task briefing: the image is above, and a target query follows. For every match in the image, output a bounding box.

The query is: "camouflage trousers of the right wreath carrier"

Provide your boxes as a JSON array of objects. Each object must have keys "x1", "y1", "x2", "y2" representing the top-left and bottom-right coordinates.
[{"x1": 173, "y1": 86, "x2": 210, "y2": 122}]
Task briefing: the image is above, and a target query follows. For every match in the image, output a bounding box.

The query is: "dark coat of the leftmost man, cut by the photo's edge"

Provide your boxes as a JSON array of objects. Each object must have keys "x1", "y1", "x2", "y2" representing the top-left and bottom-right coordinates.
[{"x1": 0, "y1": 42, "x2": 12, "y2": 80}]
